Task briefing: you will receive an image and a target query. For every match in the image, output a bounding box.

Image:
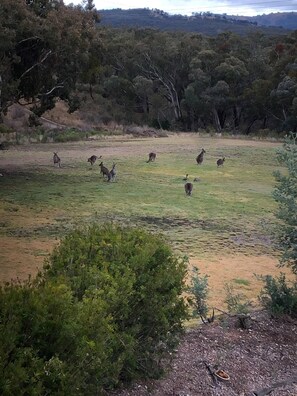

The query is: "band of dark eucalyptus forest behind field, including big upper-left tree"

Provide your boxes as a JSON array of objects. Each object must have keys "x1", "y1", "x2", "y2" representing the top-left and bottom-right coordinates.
[{"x1": 0, "y1": 0, "x2": 297, "y2": 135}]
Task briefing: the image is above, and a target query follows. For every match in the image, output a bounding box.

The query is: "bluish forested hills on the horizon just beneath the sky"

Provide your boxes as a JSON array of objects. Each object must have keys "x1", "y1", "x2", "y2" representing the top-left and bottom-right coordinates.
[{"x1": 98, "y1": 8, "x2": 297, "y2": 35}]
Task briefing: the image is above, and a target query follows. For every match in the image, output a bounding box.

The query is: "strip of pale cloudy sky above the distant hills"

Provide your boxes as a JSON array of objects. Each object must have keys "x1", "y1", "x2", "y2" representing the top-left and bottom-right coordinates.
[{"x1": 64, "y1": 0, "x2": 297, "y2": 16}]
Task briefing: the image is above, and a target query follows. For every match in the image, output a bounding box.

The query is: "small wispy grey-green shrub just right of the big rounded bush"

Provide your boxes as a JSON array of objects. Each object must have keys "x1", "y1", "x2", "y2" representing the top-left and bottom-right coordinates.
[{"x1": 188, "y1": 267, "x2": 209, "y2": 320}]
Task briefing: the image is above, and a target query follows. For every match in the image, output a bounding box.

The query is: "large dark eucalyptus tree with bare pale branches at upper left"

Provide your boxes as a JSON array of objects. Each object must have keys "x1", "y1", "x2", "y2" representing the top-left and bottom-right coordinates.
[{"x1": 0, "y1": 0, "x2": 100, "y2": 120}]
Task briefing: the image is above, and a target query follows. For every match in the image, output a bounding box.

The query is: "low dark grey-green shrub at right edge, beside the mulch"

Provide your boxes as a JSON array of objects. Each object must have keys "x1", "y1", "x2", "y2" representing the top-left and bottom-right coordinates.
[{"x1": 259, "y1": 273, "x2": 297, "y2": 317}]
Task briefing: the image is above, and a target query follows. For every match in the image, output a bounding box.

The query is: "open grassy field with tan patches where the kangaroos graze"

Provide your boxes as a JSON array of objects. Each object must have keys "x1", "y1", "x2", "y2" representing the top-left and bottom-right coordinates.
[{"x1": 0, "y1": 134, "x2": 288, "y2": 306}]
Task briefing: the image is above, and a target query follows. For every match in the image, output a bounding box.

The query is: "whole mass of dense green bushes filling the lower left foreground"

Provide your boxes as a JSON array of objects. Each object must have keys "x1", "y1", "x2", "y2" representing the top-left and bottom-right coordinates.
[{"x1": 0, "y1": 226, "x2": 187, "y2": 395}]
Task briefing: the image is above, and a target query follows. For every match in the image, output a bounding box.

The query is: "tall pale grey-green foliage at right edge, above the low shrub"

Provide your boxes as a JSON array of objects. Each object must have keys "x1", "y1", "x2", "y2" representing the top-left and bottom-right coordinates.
[{"x1": 273, "y1": 134, "x2": 297, "y2": 275}]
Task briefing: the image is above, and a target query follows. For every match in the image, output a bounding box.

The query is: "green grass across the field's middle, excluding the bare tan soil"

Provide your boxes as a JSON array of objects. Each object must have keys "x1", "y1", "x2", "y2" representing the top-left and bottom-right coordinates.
[{"x1": 0, "y1": 139, "x2": 278, "y2": 256}]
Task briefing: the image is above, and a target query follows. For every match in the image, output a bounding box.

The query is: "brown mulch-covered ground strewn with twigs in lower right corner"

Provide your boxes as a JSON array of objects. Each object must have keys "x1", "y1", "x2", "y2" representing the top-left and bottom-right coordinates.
[{"x1": 111, "y1": 311, "x2": 297, "y2": 396}]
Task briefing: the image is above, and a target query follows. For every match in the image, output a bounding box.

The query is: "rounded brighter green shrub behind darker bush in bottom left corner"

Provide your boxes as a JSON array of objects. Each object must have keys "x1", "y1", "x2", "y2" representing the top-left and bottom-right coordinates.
[{"x1": 44, "y1": 226, "x2": 186, "y2": 379}]
